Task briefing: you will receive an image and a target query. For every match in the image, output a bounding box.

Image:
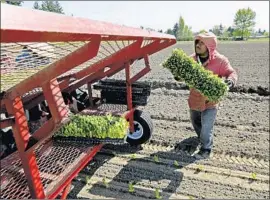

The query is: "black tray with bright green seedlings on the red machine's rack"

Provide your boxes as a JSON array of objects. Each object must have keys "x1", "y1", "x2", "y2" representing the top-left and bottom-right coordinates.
[{"x1": 53, "y1": 114, "x2": 129, "y2": 144}]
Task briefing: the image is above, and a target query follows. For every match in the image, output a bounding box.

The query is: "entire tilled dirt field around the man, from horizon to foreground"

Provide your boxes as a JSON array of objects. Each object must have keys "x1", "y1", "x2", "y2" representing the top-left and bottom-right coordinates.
[{"x1": 69, "y1": 42, "x2": 269, "y2": 199}]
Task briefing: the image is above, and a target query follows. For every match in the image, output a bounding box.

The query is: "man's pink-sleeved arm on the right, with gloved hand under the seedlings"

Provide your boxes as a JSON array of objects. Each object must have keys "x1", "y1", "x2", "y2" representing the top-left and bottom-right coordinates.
[{"x1": 220, "y1": 57, "x2": 238, "y2": 87}]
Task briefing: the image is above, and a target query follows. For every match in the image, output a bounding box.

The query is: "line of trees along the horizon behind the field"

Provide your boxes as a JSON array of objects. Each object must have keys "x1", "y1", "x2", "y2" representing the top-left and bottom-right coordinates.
[{"x1": 1, "y1": 0, "x2": 269, "y2": 41}]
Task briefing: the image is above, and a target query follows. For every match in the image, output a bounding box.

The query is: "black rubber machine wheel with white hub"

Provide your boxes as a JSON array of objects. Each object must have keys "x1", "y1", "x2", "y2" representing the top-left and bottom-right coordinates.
[{"x1": 126, "y1": 110, "x2": 153, "y2": 146}]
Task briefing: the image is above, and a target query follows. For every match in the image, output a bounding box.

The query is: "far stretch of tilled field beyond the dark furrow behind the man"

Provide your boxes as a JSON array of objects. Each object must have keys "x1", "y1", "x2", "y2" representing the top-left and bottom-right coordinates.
[{"x1": 110, "y1": 42, "x2": 270, "y2": 95}]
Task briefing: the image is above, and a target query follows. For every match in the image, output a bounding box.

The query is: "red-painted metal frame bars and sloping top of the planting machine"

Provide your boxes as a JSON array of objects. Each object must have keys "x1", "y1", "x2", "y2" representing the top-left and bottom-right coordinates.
[{"x1": 0, "y1": 4, "x2": 176, "y2": 199}]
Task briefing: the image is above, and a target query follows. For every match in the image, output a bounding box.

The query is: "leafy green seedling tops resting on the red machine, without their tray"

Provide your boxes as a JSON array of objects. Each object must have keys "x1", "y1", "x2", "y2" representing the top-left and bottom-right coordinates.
[{"x1": 55, "y1": 115, "x2": 129, "y2": 139}]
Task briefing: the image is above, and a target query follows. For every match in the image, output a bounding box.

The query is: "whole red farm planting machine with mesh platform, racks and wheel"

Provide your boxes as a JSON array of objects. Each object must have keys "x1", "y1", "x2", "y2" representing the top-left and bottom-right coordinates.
[{"x1": 0, "y1": 4, "x2": 176, "y2": 199}]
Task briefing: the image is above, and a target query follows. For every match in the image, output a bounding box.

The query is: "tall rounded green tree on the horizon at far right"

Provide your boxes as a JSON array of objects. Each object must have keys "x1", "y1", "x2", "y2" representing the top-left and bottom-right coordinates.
[{"x1": 234, "y1": 8, "x2": 256, "y2": 39}]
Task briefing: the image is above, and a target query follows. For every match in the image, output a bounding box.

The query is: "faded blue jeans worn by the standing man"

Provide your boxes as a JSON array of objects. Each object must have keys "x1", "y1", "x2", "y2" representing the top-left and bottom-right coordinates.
[{"x1": 190, "y1": 108, "x2": 217, "y2": 150}]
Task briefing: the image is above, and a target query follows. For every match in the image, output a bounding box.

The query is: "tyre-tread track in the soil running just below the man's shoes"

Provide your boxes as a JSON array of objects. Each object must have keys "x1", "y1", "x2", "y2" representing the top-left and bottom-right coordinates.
[{"x1": 101, "y1": 144, "x2": 269, "y2": 175}]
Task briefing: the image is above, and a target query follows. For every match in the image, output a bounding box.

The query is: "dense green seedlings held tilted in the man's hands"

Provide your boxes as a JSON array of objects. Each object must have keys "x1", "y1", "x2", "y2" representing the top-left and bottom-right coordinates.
[{"x1": 163, "y1": 49, "x2": 228, "y2": 102}]
